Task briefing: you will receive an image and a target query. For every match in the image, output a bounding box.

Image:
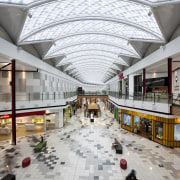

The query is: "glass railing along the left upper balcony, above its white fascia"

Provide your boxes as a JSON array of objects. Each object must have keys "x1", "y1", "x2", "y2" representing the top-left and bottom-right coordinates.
[{"x1": 0, "y1": 92, "x2": 77, "y2": 102}]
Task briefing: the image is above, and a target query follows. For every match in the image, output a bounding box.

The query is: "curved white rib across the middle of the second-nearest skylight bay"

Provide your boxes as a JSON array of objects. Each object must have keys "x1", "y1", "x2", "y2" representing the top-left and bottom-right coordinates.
[{"x1": 45, "y1": 42, "x2": 140, "y2": 58}]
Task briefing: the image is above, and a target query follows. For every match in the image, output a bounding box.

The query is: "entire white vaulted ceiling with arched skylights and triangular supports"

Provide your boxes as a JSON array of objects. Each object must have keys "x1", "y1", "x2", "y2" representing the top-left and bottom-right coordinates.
[{"x1": 0, "y1": 0, "x2": 180, "y2": 84}]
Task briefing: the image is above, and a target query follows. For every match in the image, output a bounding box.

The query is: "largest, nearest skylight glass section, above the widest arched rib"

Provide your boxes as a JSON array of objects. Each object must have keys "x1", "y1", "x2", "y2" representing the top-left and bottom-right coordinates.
[{"x1": 22, "y1": 0, "x2": 161, "y2": 40}]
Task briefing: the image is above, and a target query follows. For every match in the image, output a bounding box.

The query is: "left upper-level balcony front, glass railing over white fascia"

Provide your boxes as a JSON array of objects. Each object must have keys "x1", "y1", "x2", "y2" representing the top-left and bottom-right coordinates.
[{"x1": 0, "y1": 92, "x2": 77, "y2": 113}]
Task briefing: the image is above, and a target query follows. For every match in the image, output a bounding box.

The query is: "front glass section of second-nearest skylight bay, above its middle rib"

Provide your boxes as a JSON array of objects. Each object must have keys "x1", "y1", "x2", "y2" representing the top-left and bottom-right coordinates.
[{"x1": 48, "y1": 34, "x2": 138, "y2": 55}]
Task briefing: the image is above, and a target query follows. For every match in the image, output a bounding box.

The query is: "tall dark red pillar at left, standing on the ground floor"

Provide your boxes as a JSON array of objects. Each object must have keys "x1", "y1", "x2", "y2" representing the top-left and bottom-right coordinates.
[{"x1": 11, "y1": 59, "x2": 16, "y2": 145}]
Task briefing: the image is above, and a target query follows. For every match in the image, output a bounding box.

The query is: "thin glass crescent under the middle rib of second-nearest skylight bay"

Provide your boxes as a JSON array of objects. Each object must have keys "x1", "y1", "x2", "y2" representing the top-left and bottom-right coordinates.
[{"x1": 46, "y1": 44, "x2": 136, "y2": 57}]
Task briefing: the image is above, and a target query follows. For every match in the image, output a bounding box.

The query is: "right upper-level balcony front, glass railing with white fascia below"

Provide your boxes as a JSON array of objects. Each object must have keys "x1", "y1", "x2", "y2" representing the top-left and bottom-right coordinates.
[{"x1": 108, "y1": 91, "x2": 180, "y2": 115}]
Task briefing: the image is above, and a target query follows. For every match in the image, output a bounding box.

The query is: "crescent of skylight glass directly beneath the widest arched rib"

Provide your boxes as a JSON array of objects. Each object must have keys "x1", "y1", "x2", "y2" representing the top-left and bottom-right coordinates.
[{"x1": 21, "y1": 20, "x2": 160, "y2": 41}]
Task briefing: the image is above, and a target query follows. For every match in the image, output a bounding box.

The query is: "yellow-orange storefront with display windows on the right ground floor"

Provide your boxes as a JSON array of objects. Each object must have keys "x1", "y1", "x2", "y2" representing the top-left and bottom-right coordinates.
[{"x1": 121, "y1": 110, "x2": 180, "y2": 147}]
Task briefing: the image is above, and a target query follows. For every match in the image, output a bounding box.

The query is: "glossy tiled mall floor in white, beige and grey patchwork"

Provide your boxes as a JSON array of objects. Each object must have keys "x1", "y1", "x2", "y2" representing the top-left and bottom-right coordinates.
[{"x1": 0, "y1": 103, "x2": 180, "y2": 180}]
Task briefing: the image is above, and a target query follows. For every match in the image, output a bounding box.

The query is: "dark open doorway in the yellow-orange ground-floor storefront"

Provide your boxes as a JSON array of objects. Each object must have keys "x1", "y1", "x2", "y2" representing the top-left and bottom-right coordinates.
[{"x1": 140, "y1": 118, "x2": 152, "y2": 138}]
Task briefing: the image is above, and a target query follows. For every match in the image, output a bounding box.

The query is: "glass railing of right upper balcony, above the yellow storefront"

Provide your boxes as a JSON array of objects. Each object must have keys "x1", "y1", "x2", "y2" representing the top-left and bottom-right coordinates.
[{"x1": 108, "y1": 91, "x2": 174, "y2": 104}]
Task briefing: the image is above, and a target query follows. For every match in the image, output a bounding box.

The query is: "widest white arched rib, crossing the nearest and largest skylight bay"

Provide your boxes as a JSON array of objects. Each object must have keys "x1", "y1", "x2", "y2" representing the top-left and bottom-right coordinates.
[{"x1": 20, "y1": 17, "x2": 164, "y2": 42}]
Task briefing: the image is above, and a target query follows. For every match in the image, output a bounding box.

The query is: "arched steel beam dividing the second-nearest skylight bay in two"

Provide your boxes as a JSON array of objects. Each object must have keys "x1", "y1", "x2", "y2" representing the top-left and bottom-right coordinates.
[{"x1": 44, "y1": 42, "x2": 140, "y2": 58}]
